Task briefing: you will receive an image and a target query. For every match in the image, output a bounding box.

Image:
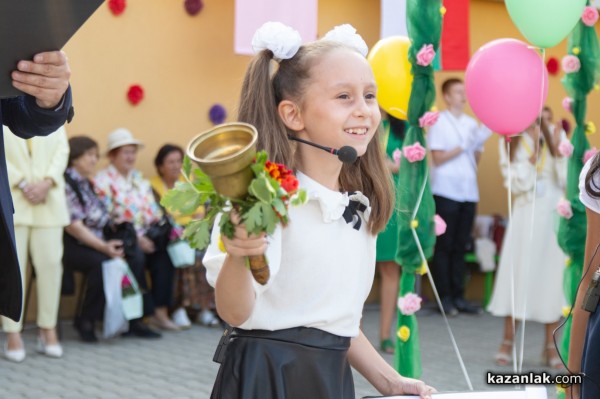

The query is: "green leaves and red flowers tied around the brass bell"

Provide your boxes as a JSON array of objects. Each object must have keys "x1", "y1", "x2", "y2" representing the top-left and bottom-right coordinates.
[{"x1": 161, "y1": 151, "x2": 307, "y2": 284}]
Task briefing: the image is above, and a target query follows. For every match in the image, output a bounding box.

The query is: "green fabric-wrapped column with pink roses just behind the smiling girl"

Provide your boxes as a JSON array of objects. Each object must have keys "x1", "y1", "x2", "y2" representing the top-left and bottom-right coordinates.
[{"x1": 394, "y1": 0, "x2": 445, "y2": 378}]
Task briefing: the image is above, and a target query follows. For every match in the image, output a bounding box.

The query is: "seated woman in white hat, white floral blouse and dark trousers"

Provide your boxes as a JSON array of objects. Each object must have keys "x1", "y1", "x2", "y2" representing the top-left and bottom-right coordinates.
[{"x1": 95, "y1": 128, "x2": 179, "y2": 331}]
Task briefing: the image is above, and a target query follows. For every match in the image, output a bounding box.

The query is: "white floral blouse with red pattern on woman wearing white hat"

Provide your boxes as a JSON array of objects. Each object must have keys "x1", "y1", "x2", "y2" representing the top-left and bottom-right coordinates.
[{"x1": 94, "y1": 165, "x2": 162, "y2": 235}]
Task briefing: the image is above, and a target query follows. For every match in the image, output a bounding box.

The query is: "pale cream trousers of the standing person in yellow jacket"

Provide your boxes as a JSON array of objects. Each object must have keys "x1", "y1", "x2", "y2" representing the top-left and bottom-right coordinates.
[{"x1": 2, "y1": 226, "x2": 63, "y2": 333}]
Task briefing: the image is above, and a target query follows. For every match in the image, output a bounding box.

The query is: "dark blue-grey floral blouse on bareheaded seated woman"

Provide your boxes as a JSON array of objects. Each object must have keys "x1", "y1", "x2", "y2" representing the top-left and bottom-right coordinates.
[{"x1": 65, "y1": 168, "x2": 110, "y2": 238}]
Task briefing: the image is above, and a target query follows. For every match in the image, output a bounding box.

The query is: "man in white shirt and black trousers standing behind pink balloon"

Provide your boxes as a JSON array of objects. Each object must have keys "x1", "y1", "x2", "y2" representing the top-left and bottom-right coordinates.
[{"x1": 427, "y1": 78, "x2": 491, "y2": 316}]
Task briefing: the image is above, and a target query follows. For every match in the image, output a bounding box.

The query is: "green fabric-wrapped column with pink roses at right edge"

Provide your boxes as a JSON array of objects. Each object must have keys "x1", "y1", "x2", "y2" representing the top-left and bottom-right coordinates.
[{"x1": 558, "y1": 1, "x2": 600, "y2": 398}]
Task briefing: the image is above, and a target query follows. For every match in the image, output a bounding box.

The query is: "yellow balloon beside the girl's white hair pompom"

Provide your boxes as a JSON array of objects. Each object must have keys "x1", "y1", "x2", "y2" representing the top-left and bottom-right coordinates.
[{"x1": 367, "y1": 36, "x2": 413, "y2": 120}]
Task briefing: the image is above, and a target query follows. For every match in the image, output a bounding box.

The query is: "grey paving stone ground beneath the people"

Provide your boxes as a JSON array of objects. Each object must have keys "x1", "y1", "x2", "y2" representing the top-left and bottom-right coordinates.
[{"x1": 0, "y1": 305, "x2": 555, "y2": 399}]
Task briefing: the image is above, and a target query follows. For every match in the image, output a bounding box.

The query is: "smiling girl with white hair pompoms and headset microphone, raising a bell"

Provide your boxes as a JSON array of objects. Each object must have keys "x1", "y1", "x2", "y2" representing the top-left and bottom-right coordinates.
[{"x1": 204, "y1": 23, "x2": 434, "y2": 399}]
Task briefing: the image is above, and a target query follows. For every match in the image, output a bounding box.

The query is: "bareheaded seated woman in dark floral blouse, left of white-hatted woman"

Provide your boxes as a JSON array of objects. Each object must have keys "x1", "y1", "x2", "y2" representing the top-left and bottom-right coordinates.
[{"x1": 63, "y1": 136, "x2": 160, "y2": 342}]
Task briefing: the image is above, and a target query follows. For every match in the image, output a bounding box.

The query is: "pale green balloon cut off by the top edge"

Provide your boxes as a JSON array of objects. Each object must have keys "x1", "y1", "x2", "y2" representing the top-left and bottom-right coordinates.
[{"x1": 506, "y1": 0, "x2": 587, "y2": 48}]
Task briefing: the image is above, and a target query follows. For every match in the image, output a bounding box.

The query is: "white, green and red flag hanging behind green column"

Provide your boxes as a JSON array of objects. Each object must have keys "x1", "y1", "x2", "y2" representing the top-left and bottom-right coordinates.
[{"x1": 381, "y1": 0, "x2": 470, "y2": 71}]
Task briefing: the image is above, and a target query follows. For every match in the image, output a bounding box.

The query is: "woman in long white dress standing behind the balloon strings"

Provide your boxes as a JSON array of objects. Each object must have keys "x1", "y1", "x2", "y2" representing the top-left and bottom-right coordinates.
[{"x1": 488, "y1": 121, "x2": 566, "y2": 368}]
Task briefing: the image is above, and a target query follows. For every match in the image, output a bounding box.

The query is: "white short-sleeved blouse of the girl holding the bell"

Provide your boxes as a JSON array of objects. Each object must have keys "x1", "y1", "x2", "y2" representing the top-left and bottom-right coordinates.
[{"x1": 203, "y1": 172, "x2": 376, "y2": 337}]
